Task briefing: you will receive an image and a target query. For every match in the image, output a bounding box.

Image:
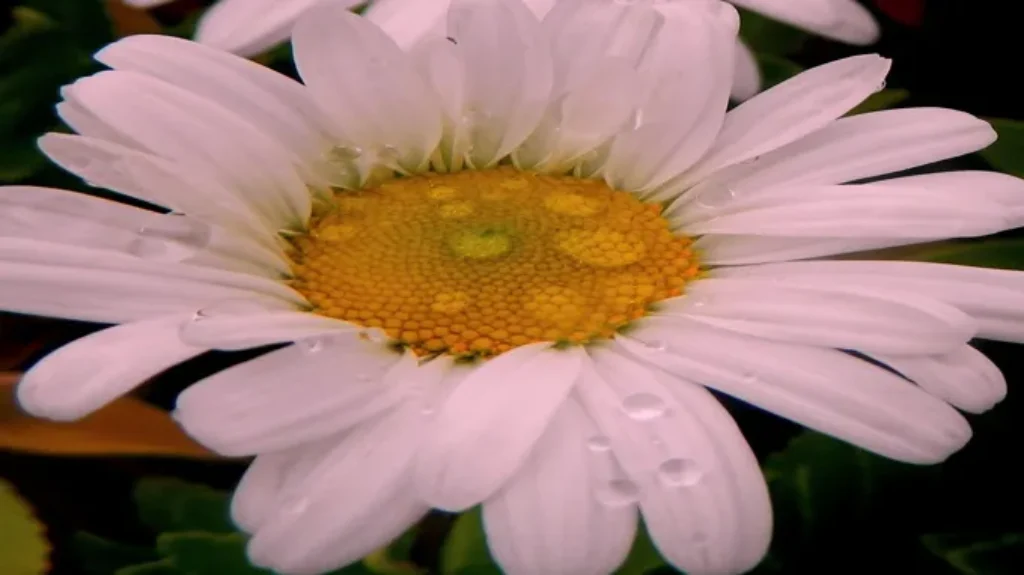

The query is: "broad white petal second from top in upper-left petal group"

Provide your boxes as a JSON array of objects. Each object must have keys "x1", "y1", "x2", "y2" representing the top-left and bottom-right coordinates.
[{"x1": 69, "y1": 72, "x2": 310, "y2": 229}]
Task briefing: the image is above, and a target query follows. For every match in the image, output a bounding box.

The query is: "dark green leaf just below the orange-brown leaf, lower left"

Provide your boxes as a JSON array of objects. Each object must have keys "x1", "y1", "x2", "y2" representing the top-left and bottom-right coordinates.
[{"x1": 134, "y1": 478, "x2": 234, "y2": 533}]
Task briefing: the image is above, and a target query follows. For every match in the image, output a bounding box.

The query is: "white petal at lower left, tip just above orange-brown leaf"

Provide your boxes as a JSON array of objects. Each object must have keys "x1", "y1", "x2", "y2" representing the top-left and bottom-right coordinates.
[{"x1": 17, "y1": 315, "x2": 206, "y2": 422}]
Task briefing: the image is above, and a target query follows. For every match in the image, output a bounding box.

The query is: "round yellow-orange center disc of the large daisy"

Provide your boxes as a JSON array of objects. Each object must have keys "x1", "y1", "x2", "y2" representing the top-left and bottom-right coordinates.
[{"x1": 294, "y1": 168, "x2": 698, "y2": 357}]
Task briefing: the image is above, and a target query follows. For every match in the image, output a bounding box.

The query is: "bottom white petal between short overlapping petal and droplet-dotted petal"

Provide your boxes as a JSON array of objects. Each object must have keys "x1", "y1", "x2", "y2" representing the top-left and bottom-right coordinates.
[{"x1": 483, "y1": 400, "x2": 637, "y2": 575}]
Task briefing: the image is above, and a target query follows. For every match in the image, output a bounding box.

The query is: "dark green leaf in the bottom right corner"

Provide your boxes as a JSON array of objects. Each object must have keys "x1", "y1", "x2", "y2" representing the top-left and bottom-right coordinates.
[{"x1": 921, "y1": 533, "x2": 1024, "y2": 575}]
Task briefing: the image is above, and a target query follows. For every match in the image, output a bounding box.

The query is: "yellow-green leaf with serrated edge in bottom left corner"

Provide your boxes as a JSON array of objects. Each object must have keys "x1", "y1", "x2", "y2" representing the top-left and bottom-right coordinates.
[{"x1": 0, "y1": 479, "x2": 50, "y2": 575}]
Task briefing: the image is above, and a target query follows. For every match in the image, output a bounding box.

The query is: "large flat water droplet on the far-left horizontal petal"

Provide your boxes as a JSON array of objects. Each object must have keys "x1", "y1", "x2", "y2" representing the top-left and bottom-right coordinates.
[{"x1": 126, "y1": 214, "x2": 212, "y2": 262}]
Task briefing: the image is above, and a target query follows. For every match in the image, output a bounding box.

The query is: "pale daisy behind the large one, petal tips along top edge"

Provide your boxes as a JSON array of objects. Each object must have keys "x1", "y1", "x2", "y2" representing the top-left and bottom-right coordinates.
[{"x1": 125, "y1": 0, "x2": 879, "y2": 100}]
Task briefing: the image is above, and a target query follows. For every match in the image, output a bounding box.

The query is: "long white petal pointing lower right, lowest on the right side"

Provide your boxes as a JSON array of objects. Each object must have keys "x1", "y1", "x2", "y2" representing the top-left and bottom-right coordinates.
[{"x1": 615, "y1": 317, "x2": 971, "y2": 463}]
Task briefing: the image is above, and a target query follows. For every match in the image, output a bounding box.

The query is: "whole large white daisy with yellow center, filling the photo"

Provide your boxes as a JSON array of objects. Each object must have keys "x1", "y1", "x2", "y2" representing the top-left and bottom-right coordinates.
[{"x1": 12, "y1": 0, "x2": 1024, "y2": 575}]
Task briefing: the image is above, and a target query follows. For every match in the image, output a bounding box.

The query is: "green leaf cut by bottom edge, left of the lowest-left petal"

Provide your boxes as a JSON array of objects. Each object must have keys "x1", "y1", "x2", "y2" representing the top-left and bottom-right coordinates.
[{"x1": 157, "y1": 533, "x2": 272, "y2": 575}]
